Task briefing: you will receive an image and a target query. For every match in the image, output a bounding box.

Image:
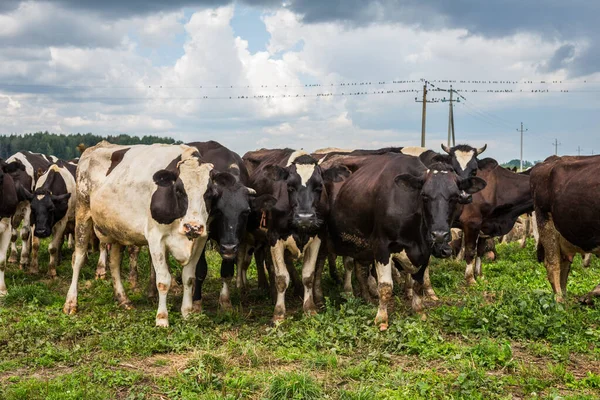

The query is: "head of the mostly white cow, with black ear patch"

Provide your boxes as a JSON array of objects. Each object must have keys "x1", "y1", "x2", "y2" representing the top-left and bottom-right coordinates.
[{"x1": 150, "y1": 146, "x2": 213, "y2": 240}]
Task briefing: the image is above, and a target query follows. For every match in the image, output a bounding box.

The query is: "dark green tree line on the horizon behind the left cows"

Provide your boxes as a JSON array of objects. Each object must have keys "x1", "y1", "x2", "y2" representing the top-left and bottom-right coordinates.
[{"x1": 0, "y1": 131, "x2": 179, "y2": 160}]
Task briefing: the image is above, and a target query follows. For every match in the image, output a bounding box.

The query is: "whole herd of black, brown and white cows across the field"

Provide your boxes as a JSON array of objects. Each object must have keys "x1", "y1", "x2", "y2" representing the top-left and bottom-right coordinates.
[{"x1": 0, "y1": 141, "x2": 600, "y2": 330}]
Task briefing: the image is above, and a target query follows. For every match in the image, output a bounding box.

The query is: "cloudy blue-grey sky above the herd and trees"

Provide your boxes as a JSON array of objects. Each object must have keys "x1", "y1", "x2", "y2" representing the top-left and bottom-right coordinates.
[{"x1": 0, "y1": 0, "x2": 600, "y2": 161}]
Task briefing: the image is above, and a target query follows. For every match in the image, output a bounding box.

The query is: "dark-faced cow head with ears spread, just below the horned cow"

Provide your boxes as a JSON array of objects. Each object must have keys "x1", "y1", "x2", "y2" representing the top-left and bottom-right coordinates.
[{"x1": 395, "y1": 163, "x2": 486, "y2": 258}]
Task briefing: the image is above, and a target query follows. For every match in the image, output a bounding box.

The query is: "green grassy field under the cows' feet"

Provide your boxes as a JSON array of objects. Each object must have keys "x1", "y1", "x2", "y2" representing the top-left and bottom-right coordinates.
[{"x1": 0, "y1": 239, "x2": 600, "y2": 400}]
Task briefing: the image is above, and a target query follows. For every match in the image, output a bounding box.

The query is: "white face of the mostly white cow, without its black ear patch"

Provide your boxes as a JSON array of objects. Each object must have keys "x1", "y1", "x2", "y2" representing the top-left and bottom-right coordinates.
[{"x1": 178, "y1": 149, "x2": 213, "y2": 237}]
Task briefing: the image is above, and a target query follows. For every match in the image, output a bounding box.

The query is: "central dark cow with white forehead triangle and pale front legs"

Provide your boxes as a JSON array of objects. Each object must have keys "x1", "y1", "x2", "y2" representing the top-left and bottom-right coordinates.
[{"x1": 242, "y1": 149, "x2": 340, "y2": 323}]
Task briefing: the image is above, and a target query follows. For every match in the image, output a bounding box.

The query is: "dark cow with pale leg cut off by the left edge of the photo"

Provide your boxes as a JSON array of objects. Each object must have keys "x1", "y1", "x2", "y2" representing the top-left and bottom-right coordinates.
[{"x1": 0, "y1": 160, "x2": 30, "y2": 297}]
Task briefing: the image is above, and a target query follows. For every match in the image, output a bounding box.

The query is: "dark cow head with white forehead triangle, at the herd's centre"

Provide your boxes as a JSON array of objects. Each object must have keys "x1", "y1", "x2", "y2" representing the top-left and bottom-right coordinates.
[{"x1": 265, "y1": 154, "x2": 324, "y2": 231}]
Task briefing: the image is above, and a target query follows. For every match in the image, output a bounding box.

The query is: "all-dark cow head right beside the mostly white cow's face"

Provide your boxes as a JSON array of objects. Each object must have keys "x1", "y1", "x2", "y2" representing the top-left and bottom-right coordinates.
[{"x1": 205, "y1": 169, "x2": 272, "y2": 259}]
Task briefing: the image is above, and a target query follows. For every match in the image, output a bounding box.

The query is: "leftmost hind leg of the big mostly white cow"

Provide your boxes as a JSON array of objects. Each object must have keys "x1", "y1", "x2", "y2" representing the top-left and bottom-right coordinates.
[{"x1": 63, "y1": 206, "x2": 92, "y2": 314}]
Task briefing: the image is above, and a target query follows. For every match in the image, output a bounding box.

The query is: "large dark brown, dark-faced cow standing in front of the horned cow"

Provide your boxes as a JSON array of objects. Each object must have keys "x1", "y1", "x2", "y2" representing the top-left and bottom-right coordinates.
[{"x1": 329, "y1": 153, "x2": 485, "y2": 330}]
